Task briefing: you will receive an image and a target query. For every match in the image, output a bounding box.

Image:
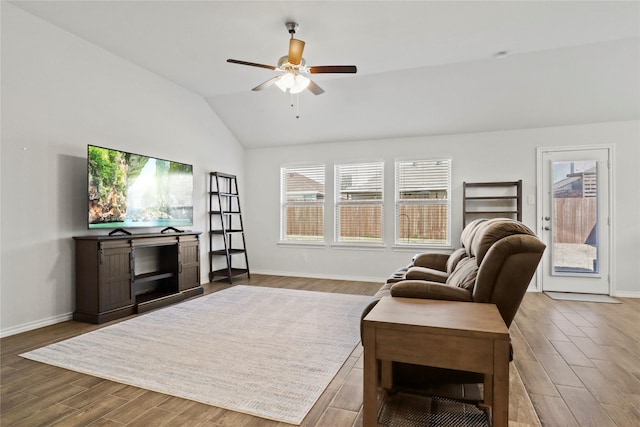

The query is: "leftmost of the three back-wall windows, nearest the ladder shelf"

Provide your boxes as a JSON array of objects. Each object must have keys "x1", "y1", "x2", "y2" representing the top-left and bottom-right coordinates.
[{"x1": 280, "y1": 165, "x2": 325, "y2": 242}]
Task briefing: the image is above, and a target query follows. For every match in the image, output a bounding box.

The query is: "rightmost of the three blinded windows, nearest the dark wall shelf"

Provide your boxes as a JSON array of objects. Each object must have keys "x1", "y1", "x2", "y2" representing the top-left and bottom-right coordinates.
[{"x1": 396, "y1": 159, "x2": 451, "y2": 246}]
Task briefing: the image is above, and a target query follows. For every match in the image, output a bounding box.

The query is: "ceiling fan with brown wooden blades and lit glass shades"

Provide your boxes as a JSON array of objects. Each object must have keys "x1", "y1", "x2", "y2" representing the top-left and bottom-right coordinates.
[{"x1": 227, "y1": 22, "x2": 357, "y2": 95}]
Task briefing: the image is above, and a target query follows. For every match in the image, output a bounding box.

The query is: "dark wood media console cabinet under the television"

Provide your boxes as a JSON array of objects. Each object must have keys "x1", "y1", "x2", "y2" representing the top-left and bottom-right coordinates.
[{"x1": 73, "y1": 232, "x2": 203, "y2": 323}]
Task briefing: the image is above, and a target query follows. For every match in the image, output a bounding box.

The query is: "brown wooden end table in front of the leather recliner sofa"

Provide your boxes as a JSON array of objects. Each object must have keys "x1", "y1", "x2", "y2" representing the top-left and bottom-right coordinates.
[{"x1": 363, "y1": 297, "x2": 509, "y2": 427}]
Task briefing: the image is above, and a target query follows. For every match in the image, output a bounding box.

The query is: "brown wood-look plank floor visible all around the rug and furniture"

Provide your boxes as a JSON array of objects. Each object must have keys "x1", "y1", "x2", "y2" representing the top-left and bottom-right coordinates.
[{"x1": 0, "y1": 275, "x2": 640, "y2": 427}]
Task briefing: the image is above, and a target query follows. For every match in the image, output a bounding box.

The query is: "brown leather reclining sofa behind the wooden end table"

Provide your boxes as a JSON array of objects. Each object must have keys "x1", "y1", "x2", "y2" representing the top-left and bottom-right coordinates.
[{"x1": 362, "y1": 218, "x2": 546, "y2": 388}]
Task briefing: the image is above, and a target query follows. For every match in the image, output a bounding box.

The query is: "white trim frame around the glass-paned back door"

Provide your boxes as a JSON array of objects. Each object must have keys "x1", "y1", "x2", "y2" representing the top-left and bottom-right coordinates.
[{"x1": 536, "y1": 144, "x2": 616, "y2": 296}]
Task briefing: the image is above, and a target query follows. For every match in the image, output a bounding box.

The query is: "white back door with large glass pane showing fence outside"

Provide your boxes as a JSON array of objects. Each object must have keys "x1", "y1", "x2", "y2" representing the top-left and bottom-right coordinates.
[{"x1": 541, "y1": 148, "x2": 610, "y2": 294}]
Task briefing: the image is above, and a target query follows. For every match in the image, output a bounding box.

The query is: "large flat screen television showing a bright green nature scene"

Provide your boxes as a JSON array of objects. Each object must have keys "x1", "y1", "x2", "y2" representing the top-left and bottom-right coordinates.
[{"x1": 87, "y1": 145, "x2": 193, "y2": 232}]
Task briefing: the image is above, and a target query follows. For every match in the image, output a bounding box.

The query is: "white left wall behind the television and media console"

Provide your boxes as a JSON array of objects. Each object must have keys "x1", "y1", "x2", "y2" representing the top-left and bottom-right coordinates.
[{"x1": 0, "y1": 2, "x2": 244, "y2": 336}]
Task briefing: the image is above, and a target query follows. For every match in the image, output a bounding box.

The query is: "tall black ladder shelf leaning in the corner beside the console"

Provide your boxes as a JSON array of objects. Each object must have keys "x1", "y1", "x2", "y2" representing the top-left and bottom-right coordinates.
[{"x1": 209, "y1": 172, "x2": 251, "y2": 283}]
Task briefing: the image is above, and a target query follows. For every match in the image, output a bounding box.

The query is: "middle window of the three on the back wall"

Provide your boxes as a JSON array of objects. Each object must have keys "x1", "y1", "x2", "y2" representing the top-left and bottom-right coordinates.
[{"x1": 335, "y1": 162, "x2": 384, "y2": 243}]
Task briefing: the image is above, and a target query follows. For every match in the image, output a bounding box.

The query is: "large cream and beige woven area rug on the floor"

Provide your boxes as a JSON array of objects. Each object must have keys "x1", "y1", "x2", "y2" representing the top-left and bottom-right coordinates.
[{"x1": 21, "y1": 286, "x2": 371, "y2": 425}]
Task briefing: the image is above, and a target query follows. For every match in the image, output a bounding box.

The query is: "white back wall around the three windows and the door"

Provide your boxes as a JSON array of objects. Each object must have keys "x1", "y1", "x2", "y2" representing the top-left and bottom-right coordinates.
[{"x1": 244, "y1": 121, "x2": 640, "y2": 297}]
